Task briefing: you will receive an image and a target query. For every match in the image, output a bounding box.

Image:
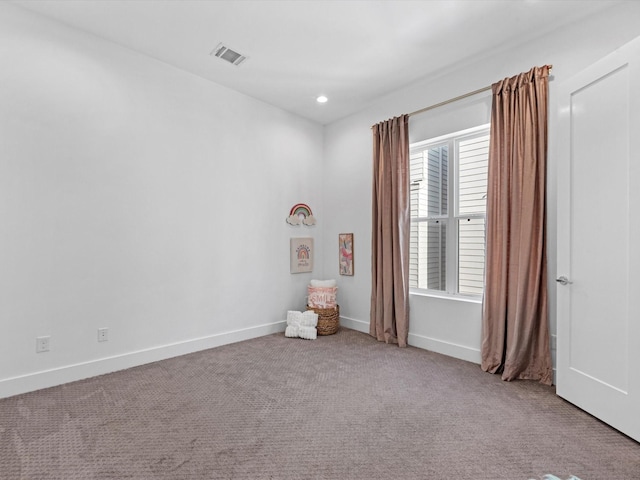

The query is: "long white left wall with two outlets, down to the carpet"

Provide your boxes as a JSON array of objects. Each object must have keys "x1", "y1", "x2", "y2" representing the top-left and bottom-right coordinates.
[{"x1": 0, "y1": 2, "x2": 324, "y2": 397}]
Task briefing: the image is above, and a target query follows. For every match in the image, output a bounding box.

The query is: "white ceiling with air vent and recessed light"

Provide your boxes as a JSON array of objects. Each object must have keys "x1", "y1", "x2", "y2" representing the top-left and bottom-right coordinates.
[{"x1": 12, "y1": 0, "x2": 619, "y2": 124}]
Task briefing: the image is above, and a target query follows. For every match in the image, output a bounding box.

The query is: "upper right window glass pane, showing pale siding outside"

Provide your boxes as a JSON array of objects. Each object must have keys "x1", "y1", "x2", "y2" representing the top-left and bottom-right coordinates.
[{"x1": 458, "y1": 134, "x2": 489, "y2": 215}]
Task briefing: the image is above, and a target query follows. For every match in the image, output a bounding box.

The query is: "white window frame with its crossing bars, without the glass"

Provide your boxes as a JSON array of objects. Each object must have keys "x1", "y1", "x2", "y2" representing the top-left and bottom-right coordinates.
[{"x1": 409, "y1": 124, "x2": 490, "y2": 301}]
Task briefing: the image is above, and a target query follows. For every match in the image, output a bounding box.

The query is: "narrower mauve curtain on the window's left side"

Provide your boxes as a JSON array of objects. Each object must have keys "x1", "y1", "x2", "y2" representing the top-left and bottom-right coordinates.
[{"x1": 369, "y1": 115, "x2": 410, "y2": 347}]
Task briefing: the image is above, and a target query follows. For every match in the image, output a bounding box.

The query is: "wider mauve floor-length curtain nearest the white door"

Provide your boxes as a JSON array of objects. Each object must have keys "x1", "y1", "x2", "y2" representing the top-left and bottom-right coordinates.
[{"x1": 481, "y1": 66, "x2": 552, "y2": 385}]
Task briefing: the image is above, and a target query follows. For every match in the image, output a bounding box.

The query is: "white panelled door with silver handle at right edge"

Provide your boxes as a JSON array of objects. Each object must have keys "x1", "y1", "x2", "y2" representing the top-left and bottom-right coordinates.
[{"x1": 556, "y1": 38, "x2": 640, "y2": 441}]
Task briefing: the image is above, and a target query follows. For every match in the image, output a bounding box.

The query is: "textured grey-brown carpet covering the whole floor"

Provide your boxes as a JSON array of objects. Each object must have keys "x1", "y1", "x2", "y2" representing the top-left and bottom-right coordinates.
[{"x1": 0, "y1": 329, "x2": 640, "y2": 480}]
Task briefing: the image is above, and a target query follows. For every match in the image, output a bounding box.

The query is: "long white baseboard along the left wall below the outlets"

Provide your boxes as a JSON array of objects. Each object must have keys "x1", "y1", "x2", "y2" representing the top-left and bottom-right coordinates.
[{"x1": 0, "y1": 320, "x2": 287, "y2": 398}]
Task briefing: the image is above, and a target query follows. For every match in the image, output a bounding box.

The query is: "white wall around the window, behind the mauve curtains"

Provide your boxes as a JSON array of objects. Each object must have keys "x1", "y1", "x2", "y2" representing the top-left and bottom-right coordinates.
[{"x1": 323, "y1": 2, "x2": 640, "y2": 363}]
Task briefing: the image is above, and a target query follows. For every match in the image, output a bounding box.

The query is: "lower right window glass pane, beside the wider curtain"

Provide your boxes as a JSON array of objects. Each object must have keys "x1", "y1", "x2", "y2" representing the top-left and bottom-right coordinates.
[{"x1": 458, "y1": 218, "x2": 485, "y2": 295}]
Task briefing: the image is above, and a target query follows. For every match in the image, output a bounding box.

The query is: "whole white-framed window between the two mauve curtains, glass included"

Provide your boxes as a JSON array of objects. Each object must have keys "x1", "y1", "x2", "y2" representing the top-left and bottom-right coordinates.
[{"x1": 409, "y1": 125, "x2": 489, "y2": 295}]
